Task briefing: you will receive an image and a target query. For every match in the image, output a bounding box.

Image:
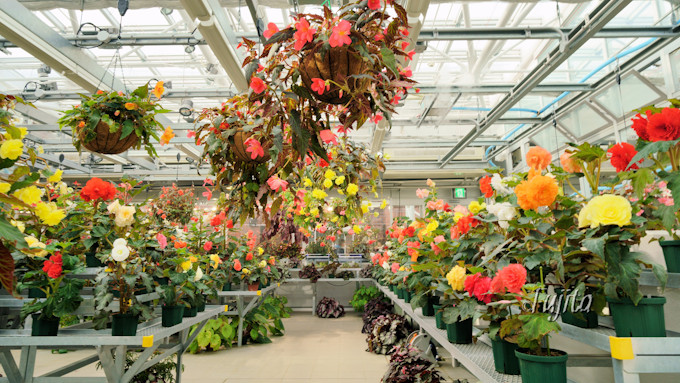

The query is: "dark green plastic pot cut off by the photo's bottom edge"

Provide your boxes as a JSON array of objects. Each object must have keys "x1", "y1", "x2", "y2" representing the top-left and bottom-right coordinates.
[{"x1": 515, "y1": 350, "x2": 569, "y2": 383}]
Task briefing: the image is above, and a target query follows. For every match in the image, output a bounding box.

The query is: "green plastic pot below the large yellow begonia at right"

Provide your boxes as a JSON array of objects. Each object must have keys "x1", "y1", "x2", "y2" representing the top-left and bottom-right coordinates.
[{"x1": 607, "y1": 297, "x2": 666, "y2": 337}]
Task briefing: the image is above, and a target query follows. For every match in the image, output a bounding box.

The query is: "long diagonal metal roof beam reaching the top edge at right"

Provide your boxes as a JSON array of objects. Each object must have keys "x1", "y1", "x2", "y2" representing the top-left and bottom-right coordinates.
[{"x1": 440, "y1": 0, "x2": 631, "y2": 168}]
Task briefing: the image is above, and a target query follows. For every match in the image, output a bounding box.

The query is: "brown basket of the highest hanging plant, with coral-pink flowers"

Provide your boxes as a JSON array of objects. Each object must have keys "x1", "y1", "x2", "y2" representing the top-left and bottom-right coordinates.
[{"x1": 300, "y1": 46, "x2": 369, "y2": 105}]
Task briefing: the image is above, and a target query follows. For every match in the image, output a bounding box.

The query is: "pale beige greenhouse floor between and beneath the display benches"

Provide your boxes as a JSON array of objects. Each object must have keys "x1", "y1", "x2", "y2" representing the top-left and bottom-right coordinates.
[{"x1": 2, "y1": 312, "x2": 476, "y2": 383}]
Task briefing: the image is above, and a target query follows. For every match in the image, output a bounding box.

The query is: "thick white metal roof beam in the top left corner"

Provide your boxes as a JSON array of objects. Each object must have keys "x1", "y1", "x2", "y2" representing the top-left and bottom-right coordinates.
[{"x1": 0, "y1": 0, "x2": 125, "y2": 92}]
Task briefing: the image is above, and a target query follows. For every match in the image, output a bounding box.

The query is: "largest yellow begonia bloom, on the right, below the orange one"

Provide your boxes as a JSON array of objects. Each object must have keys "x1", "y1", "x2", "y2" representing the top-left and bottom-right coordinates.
[{"x1": 578, "y1": 194, "x2": 632, "y2": 228}]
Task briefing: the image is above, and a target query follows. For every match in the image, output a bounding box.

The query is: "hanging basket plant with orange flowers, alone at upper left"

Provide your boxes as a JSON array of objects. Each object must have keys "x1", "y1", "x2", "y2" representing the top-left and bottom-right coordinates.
[{"x1": 59, "y1": 81, "x2": 174, "y2": 157}]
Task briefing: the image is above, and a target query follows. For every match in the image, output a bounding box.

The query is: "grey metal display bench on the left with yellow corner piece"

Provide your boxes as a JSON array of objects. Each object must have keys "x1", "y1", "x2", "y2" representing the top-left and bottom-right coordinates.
[{"x1": 0, "y1": 305, "x2": 226, "y2": 383}]
